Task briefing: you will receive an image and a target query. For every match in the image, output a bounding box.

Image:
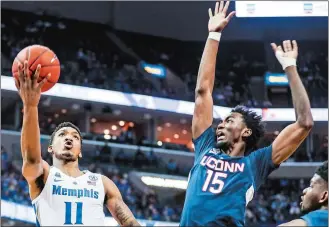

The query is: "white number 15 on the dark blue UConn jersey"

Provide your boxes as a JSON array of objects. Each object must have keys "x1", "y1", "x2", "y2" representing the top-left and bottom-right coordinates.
[{"x1": 202, "y1": 169, "x2": 227, "y2": 194}]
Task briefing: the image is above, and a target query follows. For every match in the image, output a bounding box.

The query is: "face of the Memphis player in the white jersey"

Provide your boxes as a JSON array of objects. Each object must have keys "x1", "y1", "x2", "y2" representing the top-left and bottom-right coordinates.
[{"x1": 51, "y1": 127, "x2": 81, "y2": 162}]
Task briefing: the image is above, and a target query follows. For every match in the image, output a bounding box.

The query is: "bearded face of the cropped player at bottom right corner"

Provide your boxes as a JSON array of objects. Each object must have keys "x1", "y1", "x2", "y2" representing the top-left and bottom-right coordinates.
[{"x1": 300, "y1": 174, "x2": 328, "y2": 213}]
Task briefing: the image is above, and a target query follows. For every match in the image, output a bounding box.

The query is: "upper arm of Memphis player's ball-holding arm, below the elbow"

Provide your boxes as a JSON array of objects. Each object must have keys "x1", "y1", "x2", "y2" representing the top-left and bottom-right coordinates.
[{"x1": 22, "y1": 160, "x2": 50, "y2": 183}]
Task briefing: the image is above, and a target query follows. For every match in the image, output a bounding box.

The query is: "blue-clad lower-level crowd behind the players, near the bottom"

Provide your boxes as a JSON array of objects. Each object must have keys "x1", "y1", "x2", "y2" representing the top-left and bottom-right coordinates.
[{"x1": 1, "y1": 145, "x2": 316, "y2": 226}]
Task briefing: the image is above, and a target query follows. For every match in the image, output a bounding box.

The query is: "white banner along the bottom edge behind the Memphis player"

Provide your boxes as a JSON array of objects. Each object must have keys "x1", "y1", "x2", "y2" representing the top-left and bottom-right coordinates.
[{"x1": 1, "y1": 200, "x2": 179, "y2": 226}]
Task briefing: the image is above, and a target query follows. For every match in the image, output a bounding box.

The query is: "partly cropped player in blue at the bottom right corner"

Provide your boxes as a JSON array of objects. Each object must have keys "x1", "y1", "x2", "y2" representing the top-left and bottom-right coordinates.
[{"x1": 280, "y1": 161, "x2": 328, "y2": 227}]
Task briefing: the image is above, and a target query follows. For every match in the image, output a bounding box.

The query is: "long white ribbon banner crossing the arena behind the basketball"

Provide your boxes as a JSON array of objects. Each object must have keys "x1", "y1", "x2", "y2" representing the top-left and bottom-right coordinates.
[{"x1": 1, "y1": 76, "x2": 328, "y2": 121}]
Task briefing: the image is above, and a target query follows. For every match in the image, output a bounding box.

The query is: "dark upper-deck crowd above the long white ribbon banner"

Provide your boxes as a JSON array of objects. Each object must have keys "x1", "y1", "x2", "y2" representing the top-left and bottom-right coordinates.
[{"x1": 1, "y1": 10, "x2": 328, "y2": 107}]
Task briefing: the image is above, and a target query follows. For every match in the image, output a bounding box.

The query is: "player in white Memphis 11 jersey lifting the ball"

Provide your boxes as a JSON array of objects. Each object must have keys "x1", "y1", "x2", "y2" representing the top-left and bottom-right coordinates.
[{"x1": 15, "y1": 62, "x2": 139, "y2": 226}]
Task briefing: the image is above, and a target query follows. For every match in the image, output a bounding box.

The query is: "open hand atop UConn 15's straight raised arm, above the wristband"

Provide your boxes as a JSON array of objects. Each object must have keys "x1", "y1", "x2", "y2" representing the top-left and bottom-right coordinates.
[{"x1": 208, "y1": 1, "x2": 235, "y2": 32}]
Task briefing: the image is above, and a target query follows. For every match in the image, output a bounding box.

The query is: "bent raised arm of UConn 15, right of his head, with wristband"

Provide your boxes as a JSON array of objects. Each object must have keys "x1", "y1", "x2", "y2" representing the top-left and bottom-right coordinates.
[{"x1": 272, "y1": 41, "x2": 314, "y2": 164}]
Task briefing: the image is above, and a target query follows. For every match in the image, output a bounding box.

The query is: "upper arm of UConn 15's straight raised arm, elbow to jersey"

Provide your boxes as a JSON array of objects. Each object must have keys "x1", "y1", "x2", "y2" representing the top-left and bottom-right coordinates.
[{"x1": 192, "y1": 91, "x2": 213, "y2": 139}]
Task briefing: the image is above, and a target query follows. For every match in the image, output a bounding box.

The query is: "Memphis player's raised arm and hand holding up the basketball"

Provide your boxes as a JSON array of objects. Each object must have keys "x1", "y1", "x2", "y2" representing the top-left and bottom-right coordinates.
[{"x1": 15, "y1": 61, "x2": 49, "y2": 183}]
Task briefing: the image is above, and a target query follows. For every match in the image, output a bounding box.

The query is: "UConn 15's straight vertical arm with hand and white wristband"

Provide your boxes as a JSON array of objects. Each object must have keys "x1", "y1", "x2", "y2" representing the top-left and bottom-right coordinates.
[{"x1": 192, "y1": 1, "x2": 235, "y2": 139}]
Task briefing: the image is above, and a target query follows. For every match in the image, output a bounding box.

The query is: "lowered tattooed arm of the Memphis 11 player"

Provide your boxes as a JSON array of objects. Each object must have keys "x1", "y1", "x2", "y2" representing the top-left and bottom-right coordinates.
[{"x1": 102, "y1": 176, "x2": 140, "y2": 226}]
